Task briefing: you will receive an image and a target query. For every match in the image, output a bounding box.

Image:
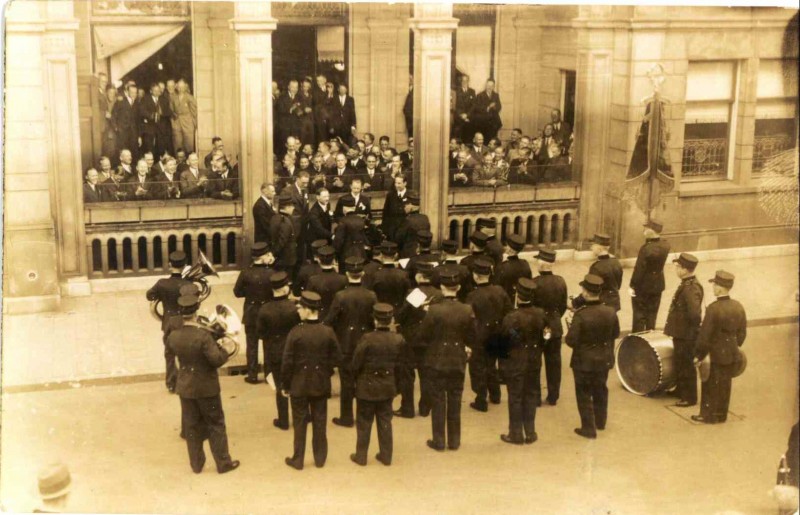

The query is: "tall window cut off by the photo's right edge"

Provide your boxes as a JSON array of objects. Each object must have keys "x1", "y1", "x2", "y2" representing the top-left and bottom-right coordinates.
[{"x1": 753, "y1": 59, "x2": 797, "y2": 173}]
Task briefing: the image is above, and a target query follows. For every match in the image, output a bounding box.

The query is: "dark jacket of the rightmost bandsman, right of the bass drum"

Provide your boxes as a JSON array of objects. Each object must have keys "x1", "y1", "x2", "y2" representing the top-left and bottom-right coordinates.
[{"x1": 695, "y1": 296, "x2": 747, "y2": 365}]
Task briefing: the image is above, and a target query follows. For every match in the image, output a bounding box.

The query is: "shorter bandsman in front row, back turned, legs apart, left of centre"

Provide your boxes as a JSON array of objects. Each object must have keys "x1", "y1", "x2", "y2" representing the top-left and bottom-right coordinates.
[{"x1": 350, "y1": 303, "x2": 406, "y2": 466}]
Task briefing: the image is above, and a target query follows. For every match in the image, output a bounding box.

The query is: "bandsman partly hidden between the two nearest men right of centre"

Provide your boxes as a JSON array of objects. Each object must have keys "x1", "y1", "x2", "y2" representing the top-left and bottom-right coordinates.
[{"x1": 466, "y1": 257, "x2": 511, "y2": 412}]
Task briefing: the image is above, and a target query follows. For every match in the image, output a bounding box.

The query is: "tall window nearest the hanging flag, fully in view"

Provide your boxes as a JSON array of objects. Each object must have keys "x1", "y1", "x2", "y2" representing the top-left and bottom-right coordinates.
[{"x1": 681, "y1": 61, "x2": 738, "y2": 180}]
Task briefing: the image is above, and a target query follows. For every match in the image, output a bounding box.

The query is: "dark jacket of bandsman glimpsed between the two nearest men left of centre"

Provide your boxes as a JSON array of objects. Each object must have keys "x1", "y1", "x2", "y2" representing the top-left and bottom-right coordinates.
[{"x1": 325, "y1": 284, "x2": 378, "y2": 357}]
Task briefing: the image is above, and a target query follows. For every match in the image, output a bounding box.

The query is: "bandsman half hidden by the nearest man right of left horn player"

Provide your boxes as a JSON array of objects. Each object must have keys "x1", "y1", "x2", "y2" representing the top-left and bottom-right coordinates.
[{"x1": 256, "y1": 272, "x2": 300, "y2": 431}]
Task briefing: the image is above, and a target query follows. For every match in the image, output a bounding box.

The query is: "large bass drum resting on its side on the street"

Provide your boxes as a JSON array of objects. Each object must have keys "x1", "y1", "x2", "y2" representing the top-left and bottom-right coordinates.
[{"x1": 616, "y1": 331, "x2": 676, "y2": 395}]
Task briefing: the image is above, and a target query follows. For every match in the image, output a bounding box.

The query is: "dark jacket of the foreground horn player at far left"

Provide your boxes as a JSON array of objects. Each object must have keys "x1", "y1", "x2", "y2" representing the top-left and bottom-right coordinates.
[{"x1": 167, "y1": 322, "x2": 228, "y2": 399}]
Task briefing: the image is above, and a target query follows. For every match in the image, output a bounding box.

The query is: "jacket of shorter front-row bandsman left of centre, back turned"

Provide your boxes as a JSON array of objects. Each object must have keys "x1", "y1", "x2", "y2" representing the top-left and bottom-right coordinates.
[{"x1": 353, "y1": 327, "x2": 406, "y2": 401}]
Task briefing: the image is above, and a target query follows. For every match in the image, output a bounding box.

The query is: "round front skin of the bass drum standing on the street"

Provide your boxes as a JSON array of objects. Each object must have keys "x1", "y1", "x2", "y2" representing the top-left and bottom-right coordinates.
[{"x1": 617, "y1": 335, "x2": 661, "y2": 395}]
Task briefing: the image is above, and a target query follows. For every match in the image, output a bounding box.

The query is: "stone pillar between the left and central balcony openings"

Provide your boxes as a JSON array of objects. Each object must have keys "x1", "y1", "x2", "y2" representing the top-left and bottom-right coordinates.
[{"x1": 230, "y1": 2, "x2": 277, "y2": 252}]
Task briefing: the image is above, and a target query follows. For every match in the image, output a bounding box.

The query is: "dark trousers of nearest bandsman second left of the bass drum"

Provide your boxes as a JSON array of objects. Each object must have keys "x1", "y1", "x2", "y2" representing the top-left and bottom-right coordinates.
[{"x1": 504, "y1": 350, "x2": 542, "y2": 441}]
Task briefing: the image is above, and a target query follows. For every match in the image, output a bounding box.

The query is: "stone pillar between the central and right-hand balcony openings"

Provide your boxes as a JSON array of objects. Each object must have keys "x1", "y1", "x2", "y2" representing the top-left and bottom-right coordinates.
[{"x1": 411, "y1": 3, "x2": 458, "y2": 248}]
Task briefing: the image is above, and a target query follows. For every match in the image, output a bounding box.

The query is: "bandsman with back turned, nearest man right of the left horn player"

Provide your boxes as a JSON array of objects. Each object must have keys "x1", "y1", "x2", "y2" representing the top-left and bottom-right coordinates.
[{"x1": 281, "y1": 291, "x2": 342, "y2": 470}]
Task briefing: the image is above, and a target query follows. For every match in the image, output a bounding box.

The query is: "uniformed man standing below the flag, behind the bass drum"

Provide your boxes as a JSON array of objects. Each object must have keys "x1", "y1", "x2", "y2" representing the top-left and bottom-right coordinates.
[{"x1": 630, "y1": 220, "x2": 670, "y2": 333}]
